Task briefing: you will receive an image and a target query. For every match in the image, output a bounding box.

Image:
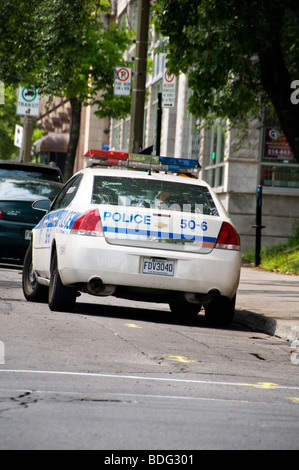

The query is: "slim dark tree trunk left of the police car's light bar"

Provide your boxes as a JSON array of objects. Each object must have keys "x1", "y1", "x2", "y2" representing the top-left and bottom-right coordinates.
[{"x1": 64, "y1": 98, "x2": 82, "y2": 181}]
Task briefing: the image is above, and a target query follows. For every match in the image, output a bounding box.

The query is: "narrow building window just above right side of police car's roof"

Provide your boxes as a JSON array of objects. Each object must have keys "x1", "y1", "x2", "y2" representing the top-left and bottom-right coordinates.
[{"x1": 205, "y1": 121, "x2": 226, "y2": 187}]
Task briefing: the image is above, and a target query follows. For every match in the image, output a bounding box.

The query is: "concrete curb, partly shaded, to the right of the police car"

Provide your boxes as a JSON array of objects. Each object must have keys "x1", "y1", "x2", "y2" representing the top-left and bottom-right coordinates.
[{"x1": 234, "y1": 309, "x2": 299, "y2": 341}]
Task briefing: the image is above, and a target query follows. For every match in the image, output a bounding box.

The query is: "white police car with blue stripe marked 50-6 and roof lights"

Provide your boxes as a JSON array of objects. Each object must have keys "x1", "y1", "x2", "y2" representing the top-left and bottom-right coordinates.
[{"x1": 23, "y1": 150, "x2": 241, "y2": 326}]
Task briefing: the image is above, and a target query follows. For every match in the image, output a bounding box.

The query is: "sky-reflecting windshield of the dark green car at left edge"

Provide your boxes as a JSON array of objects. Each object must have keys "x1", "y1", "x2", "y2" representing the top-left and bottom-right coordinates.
[{"x1": 0, "y1": 178, "x2": 62, "y2": 201}]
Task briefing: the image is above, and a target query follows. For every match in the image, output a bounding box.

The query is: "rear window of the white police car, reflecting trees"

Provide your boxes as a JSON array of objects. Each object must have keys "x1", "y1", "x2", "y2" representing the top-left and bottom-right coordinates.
[{"x1": 92, "y1": 176, "x2": 218, "y2": 216}]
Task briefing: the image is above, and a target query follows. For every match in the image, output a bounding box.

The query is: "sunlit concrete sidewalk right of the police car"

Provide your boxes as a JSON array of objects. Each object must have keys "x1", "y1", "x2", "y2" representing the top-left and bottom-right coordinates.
[{"x1": 235, "y1": 266, "x2": 299, "y2": 341}]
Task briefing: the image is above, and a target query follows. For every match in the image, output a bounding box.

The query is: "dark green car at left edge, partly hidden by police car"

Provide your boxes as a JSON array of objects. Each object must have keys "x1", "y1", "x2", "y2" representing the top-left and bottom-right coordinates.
[{"x1": 0, "y1": 177, "x2": 63, "y2": 263}]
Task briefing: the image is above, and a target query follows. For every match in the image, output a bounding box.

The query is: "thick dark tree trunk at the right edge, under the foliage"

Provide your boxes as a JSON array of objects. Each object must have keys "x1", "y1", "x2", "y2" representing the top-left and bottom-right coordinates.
[{"x1": 259, "y1": 41, "x2": 299, "y2": 163}]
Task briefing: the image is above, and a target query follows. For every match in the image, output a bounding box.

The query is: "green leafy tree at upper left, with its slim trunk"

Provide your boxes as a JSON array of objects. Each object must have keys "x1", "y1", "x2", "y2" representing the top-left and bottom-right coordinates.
[{"x1": 0, "y1": 0, "x2": 130, "y2": 178}]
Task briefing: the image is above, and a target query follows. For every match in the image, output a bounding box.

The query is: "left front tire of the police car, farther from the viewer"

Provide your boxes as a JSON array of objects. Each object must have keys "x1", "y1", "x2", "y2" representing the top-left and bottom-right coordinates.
[{"x1": 22, "y1": 244, "x2": 48, "y2": 303}]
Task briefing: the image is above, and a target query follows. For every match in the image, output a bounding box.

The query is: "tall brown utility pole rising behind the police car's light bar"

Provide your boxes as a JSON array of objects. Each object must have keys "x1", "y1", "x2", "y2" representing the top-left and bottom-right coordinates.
[{"x1": 129, "y1": 0, "x2": 150, "y2": 153}]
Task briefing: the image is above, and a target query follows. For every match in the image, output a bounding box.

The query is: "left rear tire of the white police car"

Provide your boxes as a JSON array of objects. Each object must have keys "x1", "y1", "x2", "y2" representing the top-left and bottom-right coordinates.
[{"x1": 48, "y1": 251, "x2": 77, "y2": 312}]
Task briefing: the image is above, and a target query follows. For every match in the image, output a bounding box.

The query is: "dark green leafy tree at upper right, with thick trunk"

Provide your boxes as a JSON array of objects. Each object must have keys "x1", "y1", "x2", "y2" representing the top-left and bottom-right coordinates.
[{"x1": 154, "y1": 0, "x2": 299, "y2": 162}]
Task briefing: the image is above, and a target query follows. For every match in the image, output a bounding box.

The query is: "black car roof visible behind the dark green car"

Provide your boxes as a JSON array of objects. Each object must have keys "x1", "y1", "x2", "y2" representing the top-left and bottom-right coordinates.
[{"x1": 0, "y1": 160, "x2": 63, "y2": 183}]
